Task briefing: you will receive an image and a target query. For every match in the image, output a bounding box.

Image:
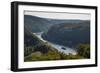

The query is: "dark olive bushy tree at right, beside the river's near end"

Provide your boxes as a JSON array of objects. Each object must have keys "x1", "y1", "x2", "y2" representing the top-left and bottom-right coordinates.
[{"x1": 77, "y1": 44, "x2": 90, "y2": 58}]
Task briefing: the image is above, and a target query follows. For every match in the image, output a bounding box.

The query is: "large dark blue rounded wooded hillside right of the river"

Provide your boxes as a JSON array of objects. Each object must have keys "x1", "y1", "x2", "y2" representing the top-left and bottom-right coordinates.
[{"x1": 42, "y1": 21, "x2": 90, "y2": 47}]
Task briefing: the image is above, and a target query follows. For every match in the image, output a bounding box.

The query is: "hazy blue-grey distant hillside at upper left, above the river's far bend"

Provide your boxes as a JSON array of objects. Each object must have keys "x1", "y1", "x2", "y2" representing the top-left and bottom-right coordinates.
[{"x1": 24, "y1": 15, "x2": 51, "y2": 32}]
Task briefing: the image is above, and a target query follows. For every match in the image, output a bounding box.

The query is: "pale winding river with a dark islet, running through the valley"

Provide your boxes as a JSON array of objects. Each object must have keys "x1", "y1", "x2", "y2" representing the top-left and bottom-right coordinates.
[{"x1": 33, "y1": 32, "x2": 77, "y2": 55}]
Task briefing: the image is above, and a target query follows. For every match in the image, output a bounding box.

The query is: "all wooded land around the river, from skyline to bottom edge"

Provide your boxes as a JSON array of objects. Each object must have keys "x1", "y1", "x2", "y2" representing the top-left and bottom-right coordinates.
[{"x1": 24, "y1": 15, "x2": 90, "y2": 62}]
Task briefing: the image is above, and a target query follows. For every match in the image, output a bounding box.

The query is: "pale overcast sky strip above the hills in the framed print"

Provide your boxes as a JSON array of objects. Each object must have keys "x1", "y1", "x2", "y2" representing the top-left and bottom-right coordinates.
[{"x1": 24, "y1": 11, "x2": 91, "y2": 20}]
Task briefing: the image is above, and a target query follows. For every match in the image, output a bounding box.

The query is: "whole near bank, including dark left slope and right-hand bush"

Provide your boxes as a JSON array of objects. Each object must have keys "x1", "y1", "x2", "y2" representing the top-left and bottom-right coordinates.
[{"x1": 24, "y1": 30, "x2": 90, "y2": 62}]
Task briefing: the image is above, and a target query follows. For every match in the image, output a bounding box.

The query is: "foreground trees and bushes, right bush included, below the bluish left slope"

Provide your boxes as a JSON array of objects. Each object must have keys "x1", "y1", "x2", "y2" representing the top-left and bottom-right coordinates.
[{"x1": 24, "y1": 43, "x2": 90, "y2": 62}]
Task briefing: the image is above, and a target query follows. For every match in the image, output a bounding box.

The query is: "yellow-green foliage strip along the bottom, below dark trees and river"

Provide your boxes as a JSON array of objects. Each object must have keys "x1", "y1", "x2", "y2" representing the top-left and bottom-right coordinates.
[{"x1": 24, "y1": 44, "x2": 84, "y2": 62}]
